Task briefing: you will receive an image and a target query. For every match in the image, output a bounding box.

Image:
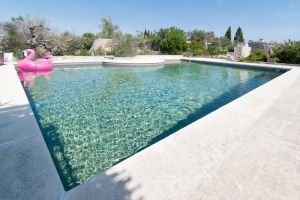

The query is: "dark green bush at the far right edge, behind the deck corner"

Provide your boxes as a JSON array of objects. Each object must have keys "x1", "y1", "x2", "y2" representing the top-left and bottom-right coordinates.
[{"x1": 272, "y1": 41, "x2": 300, "y2": 64}]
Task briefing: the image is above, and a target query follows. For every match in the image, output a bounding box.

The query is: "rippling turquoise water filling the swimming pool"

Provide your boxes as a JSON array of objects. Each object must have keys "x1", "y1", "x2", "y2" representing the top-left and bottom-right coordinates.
[{"x1": 23, "y1": 63, "x2": 281, "y2": 190}]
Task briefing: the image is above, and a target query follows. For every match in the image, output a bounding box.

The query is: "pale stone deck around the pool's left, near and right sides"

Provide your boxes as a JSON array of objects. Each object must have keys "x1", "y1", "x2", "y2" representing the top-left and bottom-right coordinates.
[{"x1": 0, "y1": 58, "x2": 300, "y2": 200}]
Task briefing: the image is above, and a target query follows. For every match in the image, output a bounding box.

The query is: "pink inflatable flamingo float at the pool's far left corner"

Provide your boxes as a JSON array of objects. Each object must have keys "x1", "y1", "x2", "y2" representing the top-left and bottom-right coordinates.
[{"x1": 18, "y1": 49, "x2": 53, "y2": 72}]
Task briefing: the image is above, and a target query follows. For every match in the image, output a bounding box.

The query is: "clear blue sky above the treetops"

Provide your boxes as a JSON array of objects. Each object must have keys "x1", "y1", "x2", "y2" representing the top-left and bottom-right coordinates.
[{"x1": 0, "y1": 0, "x2": 300, "y2": 41}]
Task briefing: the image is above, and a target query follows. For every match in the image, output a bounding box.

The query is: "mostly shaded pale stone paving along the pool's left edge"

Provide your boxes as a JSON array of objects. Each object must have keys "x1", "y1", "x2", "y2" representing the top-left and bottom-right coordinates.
[{"x1": 0, "y1": 65, "x2": 64, "y2": 200}]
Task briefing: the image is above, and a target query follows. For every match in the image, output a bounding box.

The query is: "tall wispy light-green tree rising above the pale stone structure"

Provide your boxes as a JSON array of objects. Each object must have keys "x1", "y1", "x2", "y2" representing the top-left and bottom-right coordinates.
[{"x1": 99, "y1": 17, "x2": 121, "y2": 39}]
